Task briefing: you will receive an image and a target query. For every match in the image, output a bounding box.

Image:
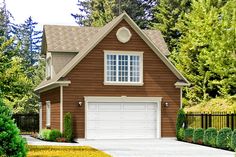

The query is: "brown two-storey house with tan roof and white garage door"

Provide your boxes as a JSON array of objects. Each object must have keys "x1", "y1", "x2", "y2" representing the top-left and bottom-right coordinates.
[{"x1": 35, "y1": 13, "x2": 189, "y2": 139}]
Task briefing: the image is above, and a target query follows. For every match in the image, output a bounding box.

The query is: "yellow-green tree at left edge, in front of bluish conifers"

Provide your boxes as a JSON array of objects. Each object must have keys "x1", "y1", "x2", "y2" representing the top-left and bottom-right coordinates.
[{"x1": 0, "y1": 37, "x2": 33, "y2": 113}]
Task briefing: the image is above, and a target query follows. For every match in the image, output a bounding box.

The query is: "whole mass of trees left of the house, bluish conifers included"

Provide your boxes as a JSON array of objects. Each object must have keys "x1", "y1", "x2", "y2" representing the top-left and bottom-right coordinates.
[{"x1": 0, "y1": 2, "x2": 44, "y2": 113}]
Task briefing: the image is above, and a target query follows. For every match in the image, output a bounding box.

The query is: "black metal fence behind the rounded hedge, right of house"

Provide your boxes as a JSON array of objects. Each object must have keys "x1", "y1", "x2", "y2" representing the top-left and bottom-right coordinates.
[{"x1": 186, "y1": 112, "x2": 236, "y2": 130}]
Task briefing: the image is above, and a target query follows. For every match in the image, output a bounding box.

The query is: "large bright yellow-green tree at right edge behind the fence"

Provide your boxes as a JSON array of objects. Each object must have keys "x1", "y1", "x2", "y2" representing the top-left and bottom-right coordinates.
[{"x1": 175, "y1": 0, "x2": 236, "y2": 103}]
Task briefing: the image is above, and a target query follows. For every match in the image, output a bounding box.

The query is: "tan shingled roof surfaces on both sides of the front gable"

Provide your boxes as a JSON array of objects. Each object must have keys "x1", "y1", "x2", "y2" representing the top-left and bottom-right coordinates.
[{"x1": 42, "y1": 25, "x2": 170, "y2": 55}]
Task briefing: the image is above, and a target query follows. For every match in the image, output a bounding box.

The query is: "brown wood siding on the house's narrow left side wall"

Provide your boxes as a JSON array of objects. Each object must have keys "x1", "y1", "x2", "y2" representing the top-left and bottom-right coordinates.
[{"x1": 40, "y1": 88, "x2": 60, "y2": 129}]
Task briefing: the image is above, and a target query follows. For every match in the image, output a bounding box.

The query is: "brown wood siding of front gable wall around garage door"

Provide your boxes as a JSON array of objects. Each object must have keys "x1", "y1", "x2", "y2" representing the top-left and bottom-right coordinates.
[{"x1": 63, "y1": 21, "x2": 180, "y2": 138}]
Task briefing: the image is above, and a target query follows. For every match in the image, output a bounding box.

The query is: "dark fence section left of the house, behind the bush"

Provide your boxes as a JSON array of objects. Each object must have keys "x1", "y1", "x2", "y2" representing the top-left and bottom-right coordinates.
[{"x1": 13, "y1": 114, "x2": 39, "y2": 134}]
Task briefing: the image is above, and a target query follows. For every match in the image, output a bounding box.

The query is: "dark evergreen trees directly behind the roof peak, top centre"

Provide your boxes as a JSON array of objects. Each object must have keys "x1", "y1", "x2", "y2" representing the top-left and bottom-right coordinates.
[{"x1": 71, "y1": 0, "x2": 156, "y2": 28}]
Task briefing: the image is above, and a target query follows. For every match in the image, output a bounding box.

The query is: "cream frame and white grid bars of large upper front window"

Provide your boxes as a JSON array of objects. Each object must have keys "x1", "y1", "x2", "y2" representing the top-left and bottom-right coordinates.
[{"x1": 104, "y1": 50, "x2": 143, "y2": 86}]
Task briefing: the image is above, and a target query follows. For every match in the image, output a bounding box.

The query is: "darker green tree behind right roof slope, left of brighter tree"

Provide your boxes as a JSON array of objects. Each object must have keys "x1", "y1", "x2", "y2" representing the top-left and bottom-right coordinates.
[{"x1": 150, "y1": 0, "x2": 191, "y2": 52}]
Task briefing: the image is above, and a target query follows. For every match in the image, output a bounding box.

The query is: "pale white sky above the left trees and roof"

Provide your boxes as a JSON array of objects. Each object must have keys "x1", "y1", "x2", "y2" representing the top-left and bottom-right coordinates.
[{"x1": 4, "y1": 0, "x2": 79, "y2": 29}]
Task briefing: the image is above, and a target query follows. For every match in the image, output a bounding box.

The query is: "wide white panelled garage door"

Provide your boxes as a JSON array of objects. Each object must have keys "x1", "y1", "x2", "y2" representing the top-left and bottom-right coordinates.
[{"x1": 86, "y1": 102, "x2": 160, "y2": 139}]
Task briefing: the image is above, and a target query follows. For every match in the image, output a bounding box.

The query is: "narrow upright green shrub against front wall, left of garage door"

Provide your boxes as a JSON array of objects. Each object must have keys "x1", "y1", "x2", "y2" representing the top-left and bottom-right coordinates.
[{"x1": 63, "y1": 112, "x2": 73, "y2": 142}]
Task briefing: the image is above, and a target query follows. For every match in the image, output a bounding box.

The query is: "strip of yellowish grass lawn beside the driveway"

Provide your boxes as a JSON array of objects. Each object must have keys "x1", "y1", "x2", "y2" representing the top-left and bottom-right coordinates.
[{"x1": 27, "y1": 145, "x2": 111, "y2": 157}]
